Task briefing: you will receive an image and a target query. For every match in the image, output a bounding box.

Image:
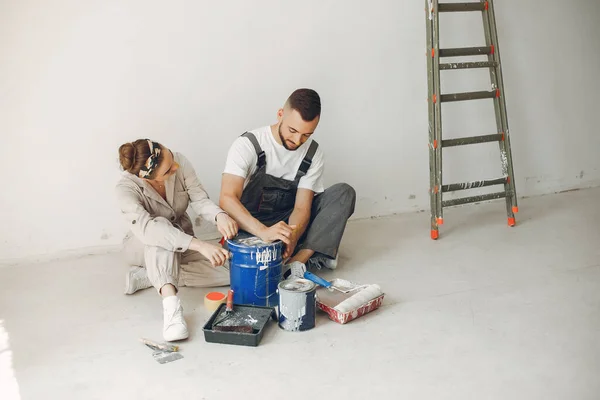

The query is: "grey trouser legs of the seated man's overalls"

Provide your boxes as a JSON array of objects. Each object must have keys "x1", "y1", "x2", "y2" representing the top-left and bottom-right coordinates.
[{"x1": 252, "y1": 183, "x2": 356, "y2": 259}]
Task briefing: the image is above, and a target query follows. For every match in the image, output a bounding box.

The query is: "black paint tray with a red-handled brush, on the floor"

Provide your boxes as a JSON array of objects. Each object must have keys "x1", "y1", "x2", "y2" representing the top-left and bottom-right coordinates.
[{"x1": 202, "y1": 304, "x2": 277, "y2": 346}]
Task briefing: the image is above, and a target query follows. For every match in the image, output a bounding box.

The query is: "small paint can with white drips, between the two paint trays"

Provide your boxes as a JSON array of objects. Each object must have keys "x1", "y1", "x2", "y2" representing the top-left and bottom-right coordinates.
[{"x1": 278, "y1": 278, "x2": 317, "y2": 332}]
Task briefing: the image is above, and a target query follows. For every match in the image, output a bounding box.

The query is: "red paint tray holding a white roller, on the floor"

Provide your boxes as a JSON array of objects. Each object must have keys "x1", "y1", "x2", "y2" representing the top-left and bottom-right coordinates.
[{"x1": 317, "y1": 279, "x2": 385, "y2": 325}]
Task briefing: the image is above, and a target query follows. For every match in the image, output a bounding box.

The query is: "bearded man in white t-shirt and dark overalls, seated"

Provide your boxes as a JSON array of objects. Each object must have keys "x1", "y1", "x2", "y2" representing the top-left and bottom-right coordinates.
[{"x1": 220, "y1": 89, "x2": 356, "y2": 269}]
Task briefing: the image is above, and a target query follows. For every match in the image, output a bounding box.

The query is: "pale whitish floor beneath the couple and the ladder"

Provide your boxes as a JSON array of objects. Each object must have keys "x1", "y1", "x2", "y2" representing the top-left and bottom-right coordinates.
[{"x1": 0, "y1": 188, "x2": 600, "y2": 400}]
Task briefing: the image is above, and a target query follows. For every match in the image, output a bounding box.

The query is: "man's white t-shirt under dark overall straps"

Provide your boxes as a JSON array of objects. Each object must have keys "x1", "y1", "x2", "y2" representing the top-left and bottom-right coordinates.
[{"x1": 224, "y1": 126, "x2": 325, "y2": 193}]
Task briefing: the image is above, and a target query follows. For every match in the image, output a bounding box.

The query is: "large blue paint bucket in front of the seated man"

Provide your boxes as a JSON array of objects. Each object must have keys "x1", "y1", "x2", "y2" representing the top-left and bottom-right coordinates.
[{"x1": 227, "y1": 237, "x2": 283, "y2": 307}]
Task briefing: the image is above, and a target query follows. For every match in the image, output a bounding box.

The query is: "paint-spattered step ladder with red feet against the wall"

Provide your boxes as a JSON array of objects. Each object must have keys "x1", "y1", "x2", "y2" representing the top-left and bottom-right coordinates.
[{"x1": 425, "y1": 0, "x2": 519, "y2": 240}]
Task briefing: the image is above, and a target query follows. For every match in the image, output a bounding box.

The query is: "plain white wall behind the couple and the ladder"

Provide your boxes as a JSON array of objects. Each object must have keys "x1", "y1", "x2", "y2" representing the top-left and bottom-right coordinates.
[{"x1": 0, "y1": 0, "x2": 600, "y2": 260}]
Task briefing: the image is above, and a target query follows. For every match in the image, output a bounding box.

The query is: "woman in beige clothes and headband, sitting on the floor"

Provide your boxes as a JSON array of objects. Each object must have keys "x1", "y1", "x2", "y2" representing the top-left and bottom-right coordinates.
[{"x1": 116, "y1": 139, "x2": 238, "y2": 341}]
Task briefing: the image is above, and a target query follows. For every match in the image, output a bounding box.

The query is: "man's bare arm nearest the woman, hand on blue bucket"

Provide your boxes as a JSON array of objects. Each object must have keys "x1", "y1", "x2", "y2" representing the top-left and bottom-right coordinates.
[{"x1": 219, "y1": 173, "x2": 296, "y2": 245}]
